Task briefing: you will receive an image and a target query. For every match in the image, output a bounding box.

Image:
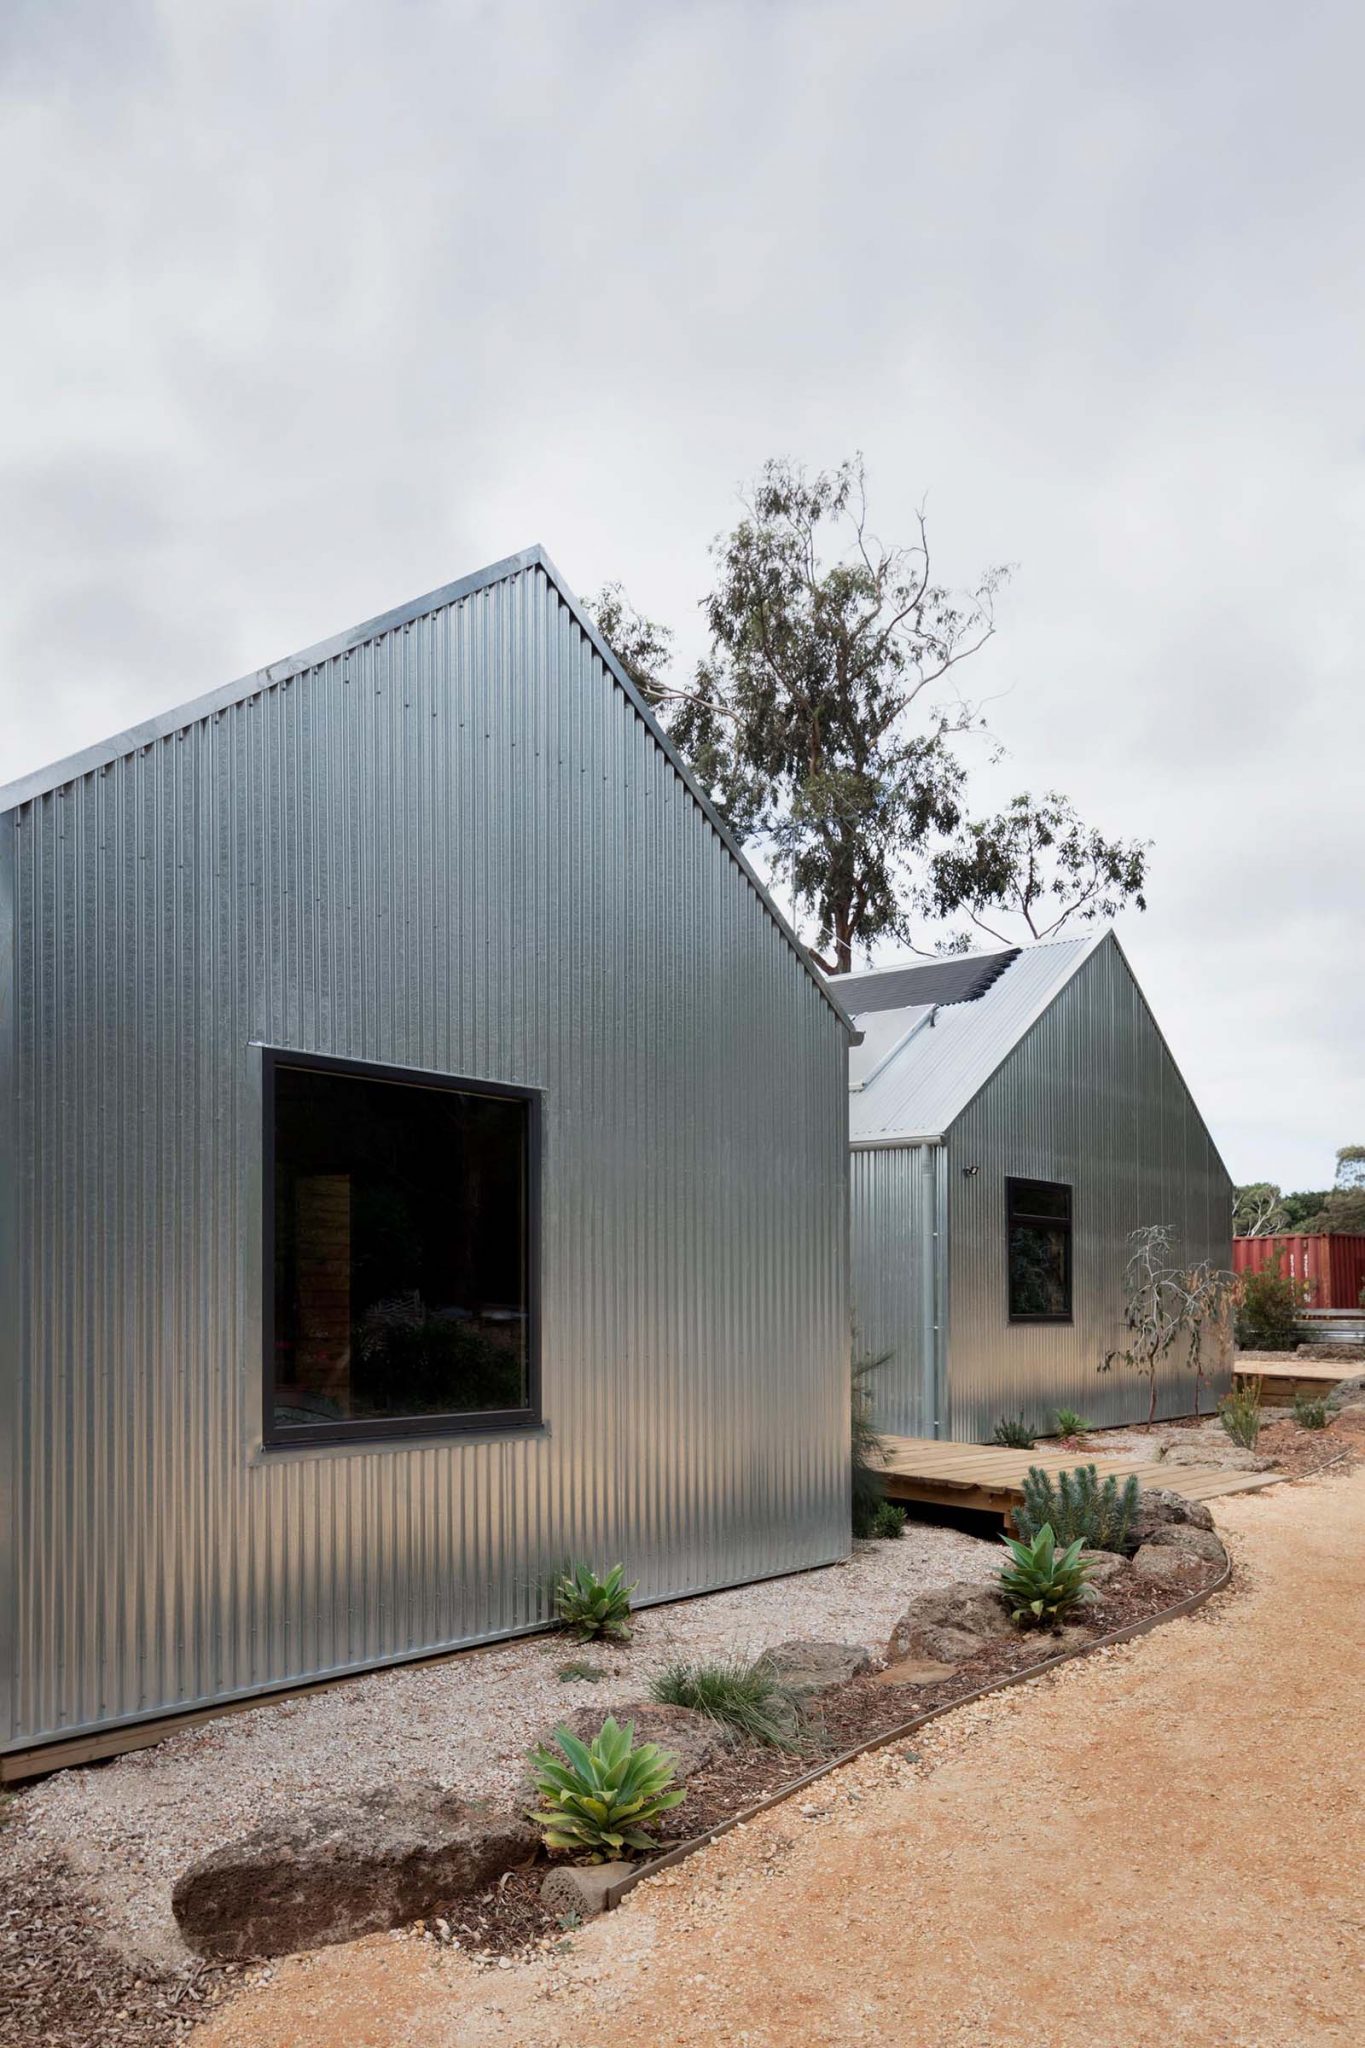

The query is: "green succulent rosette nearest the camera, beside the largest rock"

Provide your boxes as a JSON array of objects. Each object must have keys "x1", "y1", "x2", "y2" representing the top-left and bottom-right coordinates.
[{"x1": 528, "y1": 1714, "x2": 688, "y2": 1864}]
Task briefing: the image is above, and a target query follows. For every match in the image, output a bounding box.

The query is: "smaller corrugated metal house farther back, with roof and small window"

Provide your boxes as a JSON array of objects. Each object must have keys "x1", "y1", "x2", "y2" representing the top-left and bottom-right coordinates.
[{"x1": 831, "y1": 930, "x2": 1232, "y2": 1442}]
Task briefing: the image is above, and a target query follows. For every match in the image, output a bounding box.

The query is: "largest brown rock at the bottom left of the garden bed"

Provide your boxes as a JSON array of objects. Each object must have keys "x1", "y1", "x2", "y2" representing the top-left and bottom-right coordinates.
[{"x1": 170, "y1": 1782, "x2": 538, "y2": 1962}]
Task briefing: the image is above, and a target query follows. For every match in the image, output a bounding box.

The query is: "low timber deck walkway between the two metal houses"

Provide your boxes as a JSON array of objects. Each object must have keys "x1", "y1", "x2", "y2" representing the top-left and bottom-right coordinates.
[{"x1": 882, "y1": 1436, "x2": 1285, "y2": 1518}]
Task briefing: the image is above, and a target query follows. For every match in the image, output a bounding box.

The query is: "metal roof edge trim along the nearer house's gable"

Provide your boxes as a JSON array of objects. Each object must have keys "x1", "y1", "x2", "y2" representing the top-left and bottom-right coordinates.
[{"x1": 0, "y1": 545, "x2": 853, "y2": 1034}]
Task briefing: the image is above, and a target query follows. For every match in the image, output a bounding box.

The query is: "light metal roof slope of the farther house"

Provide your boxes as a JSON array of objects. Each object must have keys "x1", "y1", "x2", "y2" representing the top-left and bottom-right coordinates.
[{"x1": 833, "y1": 926, "x2": 1111, "y2": 1145}]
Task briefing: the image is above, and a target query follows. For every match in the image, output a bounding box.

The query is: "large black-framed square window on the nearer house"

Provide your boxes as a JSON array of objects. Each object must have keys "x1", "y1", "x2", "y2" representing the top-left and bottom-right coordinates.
[{"x1": 264, "y1": 1051, "x2": 540, "y2": 1444}]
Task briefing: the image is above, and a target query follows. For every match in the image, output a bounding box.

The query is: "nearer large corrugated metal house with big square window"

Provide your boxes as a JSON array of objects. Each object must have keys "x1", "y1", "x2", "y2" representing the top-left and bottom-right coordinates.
[{"x1": 0, "y1": 549, "x2": 849, "y2": 1753}]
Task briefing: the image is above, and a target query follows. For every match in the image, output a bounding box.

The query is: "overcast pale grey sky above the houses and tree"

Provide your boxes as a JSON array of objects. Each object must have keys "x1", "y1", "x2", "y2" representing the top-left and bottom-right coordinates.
[{"x1": 0, "y1": 0, "x2": 1365, "y2": 1186}]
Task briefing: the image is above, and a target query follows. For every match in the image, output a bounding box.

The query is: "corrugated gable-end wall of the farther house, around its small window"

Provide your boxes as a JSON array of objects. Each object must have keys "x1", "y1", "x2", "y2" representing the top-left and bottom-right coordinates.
[{"x1": 948, "y1": 940, "x2": 1232, "y2": 1440}]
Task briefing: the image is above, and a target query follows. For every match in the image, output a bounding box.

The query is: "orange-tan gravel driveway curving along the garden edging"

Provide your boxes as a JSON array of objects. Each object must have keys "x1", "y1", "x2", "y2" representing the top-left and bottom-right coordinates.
[{"x1": 194, "y1": 1468, "x2": 1365, "y2": 2048}]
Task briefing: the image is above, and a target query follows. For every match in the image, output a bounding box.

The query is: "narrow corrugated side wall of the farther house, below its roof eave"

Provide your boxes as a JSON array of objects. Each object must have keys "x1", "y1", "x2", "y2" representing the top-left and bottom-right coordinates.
[{"x1": 849, "y1": 1145, "x2": 948, "y2": 1436}]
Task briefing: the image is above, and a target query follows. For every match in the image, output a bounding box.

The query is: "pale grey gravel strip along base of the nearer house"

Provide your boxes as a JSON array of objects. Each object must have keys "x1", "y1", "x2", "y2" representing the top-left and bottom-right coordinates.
[{"x1": 6, "y1": 1524, "x2": 999, "y2": 1974}]
